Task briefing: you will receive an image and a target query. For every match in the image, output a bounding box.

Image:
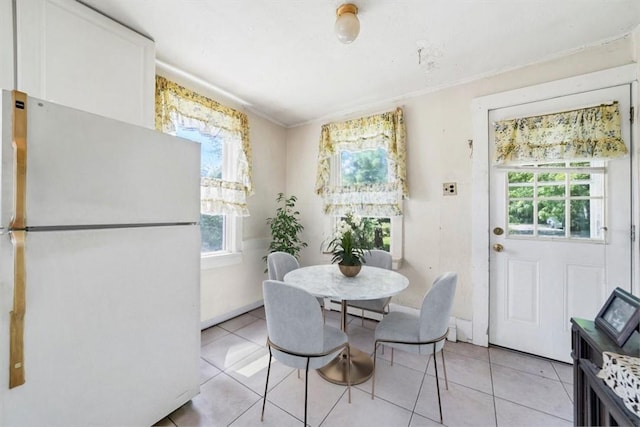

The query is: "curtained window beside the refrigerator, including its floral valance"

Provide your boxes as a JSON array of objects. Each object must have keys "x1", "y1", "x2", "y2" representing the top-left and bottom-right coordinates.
[{"x1": 156, "y1": 76, "x2": 252, "y2": 257}]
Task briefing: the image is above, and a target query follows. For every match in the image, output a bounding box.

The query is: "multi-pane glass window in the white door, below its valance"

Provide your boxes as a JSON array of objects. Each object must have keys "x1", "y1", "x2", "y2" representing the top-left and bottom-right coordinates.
[{"x1": 507, "y1": 161, "x2": 606, "y2": 241}]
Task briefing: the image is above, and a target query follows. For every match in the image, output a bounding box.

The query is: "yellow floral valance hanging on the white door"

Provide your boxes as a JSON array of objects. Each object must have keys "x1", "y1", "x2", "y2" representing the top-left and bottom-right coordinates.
[{"x1": 494, "y1": 102, "x2": 627, "y2": 165}]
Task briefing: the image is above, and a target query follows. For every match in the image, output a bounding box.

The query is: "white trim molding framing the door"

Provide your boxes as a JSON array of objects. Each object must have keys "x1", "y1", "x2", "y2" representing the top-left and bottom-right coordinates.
[{"x1": 471, "y1": 64, "x2": 640, "y2": 347}]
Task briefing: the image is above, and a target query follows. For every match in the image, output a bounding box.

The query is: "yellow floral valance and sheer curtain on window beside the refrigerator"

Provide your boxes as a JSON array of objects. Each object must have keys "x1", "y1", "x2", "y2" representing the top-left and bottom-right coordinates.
[{"x1": 155, "y1": 76, "x2": 253, "y2": 216}]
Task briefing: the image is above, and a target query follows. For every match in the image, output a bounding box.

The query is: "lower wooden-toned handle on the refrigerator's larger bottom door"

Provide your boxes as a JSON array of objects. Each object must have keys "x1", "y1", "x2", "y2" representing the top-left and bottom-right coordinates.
[{"x1": 9, "y1": 230, "x2": 27, "y2": 388}]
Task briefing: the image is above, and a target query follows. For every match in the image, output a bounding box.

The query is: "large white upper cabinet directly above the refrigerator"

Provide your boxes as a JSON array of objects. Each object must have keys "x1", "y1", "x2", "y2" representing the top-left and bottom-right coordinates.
[{"x1": 15, "y1": 0, "x2": 155, "y2": 128}]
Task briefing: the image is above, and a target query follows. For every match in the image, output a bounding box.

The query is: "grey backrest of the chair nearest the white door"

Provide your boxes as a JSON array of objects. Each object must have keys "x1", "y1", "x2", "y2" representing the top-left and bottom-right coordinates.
[{"x1": 420, "y1": 272, "x2": 458, "y2": 341}]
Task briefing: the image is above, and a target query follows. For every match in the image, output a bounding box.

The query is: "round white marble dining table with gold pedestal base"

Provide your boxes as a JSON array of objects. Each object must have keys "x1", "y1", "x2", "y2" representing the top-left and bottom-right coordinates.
[{"x1": 284, "y1": 264, "x2": 409, "y2": 385}]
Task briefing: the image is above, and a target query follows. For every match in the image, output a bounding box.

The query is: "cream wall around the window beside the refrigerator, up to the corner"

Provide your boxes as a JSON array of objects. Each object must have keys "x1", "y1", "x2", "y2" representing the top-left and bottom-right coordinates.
[{"x1": 157, "y1": 65, "x2": 286, "y2": 326}]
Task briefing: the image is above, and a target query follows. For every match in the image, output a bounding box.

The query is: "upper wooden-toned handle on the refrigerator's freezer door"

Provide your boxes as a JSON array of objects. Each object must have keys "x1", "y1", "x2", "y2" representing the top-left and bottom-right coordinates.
[{"x1": 9, "y1": 90, "x2": 27, "y2": 229}]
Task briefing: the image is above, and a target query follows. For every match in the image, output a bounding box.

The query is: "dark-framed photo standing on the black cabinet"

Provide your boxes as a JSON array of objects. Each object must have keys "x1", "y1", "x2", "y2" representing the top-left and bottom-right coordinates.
[{"x1": 596, "y1": 288, "x2": 640, "y2": 347}]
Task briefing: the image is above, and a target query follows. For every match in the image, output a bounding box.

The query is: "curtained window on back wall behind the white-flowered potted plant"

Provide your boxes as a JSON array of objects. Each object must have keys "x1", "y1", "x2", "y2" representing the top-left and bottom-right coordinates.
[{"x1": 316, "y1": 108, "x2": 408, "y2": 262}]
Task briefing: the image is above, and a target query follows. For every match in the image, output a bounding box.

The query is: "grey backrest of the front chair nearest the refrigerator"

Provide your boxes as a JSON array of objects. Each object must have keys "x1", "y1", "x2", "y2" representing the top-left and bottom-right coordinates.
[{"x1": 262, "y1": 280, "x2": 324, "y2": 354}]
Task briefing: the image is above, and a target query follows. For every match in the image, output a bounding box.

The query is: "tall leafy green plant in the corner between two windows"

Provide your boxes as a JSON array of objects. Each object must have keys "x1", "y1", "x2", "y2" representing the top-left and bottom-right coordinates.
[{"x1": 262, "y1": 193, "x2": 307, "y2": 268}]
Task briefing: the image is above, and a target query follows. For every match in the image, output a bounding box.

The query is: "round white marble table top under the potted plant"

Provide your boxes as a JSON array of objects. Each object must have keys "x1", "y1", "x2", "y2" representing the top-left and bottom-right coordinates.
[{"x1": 284, "y1": 264, "x2": 409, "y2": 300}]
